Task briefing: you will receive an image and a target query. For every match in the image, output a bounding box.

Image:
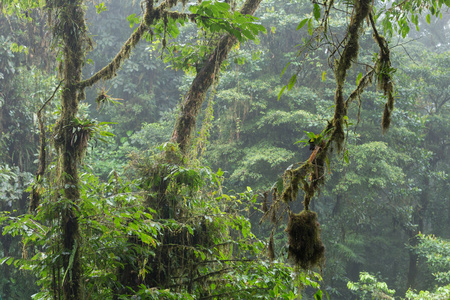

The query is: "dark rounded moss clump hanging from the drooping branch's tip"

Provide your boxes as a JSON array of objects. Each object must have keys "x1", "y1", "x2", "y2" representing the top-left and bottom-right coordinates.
[{"x1": 285, "y1": 210, "x2": 325, "y2": 270}]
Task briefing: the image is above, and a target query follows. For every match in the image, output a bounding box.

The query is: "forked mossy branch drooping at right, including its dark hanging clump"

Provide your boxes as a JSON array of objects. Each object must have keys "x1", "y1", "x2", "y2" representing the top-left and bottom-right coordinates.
[{"x1": 261, "y1": 0, "x2": 400, "y2": 269}]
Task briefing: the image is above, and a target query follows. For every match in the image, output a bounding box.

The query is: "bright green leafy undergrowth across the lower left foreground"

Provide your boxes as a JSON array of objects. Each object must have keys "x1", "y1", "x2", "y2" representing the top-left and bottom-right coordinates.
[{"x1": 1, "y1": 150, "x2": 320, "y2": 299}]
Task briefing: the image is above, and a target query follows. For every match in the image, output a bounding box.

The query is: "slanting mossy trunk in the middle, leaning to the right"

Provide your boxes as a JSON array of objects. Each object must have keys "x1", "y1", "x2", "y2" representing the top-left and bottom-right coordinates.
[{"x1": 171, "y1": 0, "x2": 261, "y2": 153}]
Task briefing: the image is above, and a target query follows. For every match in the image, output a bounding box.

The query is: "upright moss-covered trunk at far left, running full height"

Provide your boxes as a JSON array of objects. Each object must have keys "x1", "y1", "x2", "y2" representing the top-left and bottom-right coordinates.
[{"x1": 52, "y1": 0, "x2": 86, "y2": 299}]
